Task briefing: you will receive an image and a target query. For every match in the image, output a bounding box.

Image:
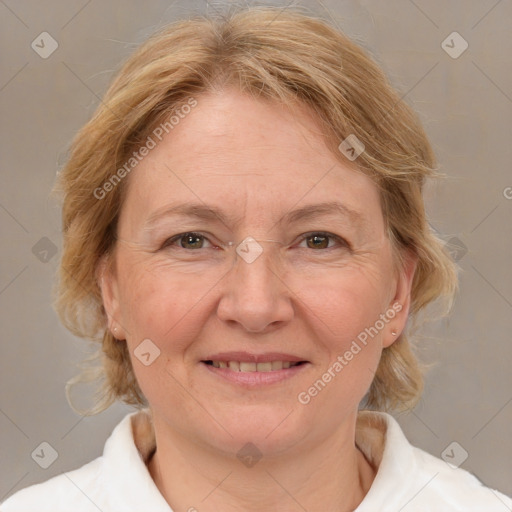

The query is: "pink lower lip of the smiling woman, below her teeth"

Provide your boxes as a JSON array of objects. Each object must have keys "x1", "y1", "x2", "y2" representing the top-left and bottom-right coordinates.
[{"x1": 200, "y1": 358, "x2": 310, "y2": 388}]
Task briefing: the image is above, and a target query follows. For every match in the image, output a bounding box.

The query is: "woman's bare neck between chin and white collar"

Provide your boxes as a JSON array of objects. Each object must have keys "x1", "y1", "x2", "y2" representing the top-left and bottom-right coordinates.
[{"x1": 148, "y1": 412, "x2": 376, "y2": 512}]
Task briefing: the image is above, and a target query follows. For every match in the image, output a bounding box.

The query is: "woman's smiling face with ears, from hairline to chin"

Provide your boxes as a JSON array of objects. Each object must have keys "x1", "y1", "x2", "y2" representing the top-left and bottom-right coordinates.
[{"x1": 102, "y1": 90, "x2": 414, "y2": 453}]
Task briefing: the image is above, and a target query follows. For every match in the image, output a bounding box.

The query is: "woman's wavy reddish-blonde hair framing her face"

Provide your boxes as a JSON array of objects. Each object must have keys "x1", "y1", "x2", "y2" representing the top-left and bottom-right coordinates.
[{"x1": 55, "y1": 7, "x2": 457, "y2": 414}]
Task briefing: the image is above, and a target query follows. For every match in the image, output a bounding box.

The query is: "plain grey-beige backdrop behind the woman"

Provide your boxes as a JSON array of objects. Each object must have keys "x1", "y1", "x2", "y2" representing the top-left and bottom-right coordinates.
[{"x1": 0, "y1": 0, "x2": 512, "y2": 501}]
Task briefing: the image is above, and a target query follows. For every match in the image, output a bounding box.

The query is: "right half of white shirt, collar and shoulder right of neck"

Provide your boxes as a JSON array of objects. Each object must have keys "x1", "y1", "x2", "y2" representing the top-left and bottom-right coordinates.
[{"x1": 357, "y1": 411, "x2": 512, "y2": 512}]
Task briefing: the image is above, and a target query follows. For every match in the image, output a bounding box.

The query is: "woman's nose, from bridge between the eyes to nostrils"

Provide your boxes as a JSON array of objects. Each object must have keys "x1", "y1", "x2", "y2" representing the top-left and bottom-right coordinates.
[{"x1": 217, "y1": 239, "x2": 294, "y2": 332}]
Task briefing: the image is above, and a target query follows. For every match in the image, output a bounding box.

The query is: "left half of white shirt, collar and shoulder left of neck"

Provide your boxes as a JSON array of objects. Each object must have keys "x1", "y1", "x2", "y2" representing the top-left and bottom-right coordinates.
[{"x1": 0, "y1": 411, "x2": 170, "y2": 512}]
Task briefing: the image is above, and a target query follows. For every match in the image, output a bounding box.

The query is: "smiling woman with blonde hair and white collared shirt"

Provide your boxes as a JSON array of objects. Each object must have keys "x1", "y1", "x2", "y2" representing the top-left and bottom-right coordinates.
[{"x1": 2, "y1": 8, "x2": 512, "y2": 512}]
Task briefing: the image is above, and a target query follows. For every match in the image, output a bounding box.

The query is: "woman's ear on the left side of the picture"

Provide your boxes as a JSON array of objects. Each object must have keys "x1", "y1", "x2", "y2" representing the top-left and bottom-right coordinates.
[{"x1": 96, "y1": 254, "x2": 126, "y2": 340}]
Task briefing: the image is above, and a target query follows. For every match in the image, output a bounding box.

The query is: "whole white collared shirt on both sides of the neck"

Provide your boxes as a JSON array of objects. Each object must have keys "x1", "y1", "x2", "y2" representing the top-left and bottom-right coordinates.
[{"x1": 0, "y1": 410, "x2": 512, "y2": 512}]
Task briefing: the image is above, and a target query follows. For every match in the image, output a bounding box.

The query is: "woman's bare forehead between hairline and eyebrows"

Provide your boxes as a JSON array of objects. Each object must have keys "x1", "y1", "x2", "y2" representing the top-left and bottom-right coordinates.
[{"x1": 123, "y1": 90, "x2": 382, "y2": 236}]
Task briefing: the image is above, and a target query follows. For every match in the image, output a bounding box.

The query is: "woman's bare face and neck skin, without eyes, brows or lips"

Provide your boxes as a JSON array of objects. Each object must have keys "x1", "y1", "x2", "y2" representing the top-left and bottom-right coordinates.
[{"x1": 102, "y1": 91, "x2": 414, "y2": 512}]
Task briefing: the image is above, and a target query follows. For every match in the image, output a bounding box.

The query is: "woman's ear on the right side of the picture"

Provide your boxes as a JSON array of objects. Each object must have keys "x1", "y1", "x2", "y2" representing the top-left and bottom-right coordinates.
[{"x1": 382, "y1": 250, "x2": 418, "y2": 348}]
